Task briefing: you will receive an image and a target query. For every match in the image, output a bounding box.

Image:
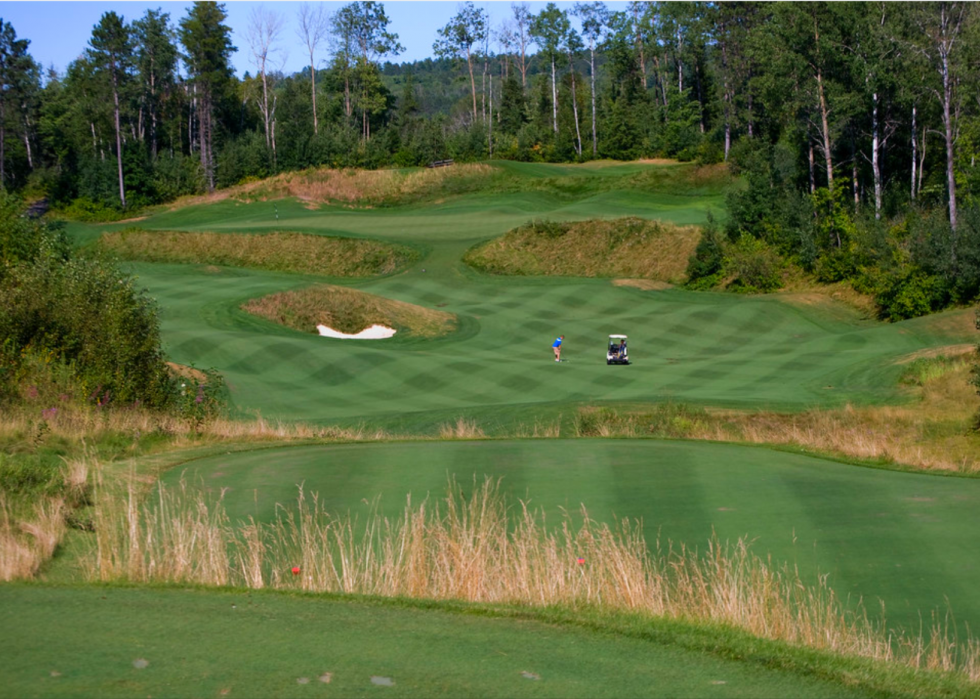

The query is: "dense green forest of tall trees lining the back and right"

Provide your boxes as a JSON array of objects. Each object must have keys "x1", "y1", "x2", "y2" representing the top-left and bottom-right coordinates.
[{"x1": 0, "y1": 2, "x2": 980, "y2": 319}]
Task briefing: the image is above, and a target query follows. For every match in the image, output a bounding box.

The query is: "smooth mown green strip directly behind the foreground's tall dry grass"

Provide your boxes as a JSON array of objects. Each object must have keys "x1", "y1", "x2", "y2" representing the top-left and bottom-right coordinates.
[{"x1": 172, "y1": 440, "x2": 980, "y2": 629}]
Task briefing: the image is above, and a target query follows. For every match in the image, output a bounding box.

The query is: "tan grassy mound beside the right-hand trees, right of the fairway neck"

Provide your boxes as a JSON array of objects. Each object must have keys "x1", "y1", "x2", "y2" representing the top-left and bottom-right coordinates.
[{"x1": 463, "y1": 217, "x2": 700, "y2": 282}]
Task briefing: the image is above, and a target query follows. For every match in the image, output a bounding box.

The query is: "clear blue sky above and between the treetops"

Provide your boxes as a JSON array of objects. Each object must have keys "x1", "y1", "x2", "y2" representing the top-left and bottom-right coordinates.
[{"x1": 0, "y1": 0, "x2": 626, "y2": 76}]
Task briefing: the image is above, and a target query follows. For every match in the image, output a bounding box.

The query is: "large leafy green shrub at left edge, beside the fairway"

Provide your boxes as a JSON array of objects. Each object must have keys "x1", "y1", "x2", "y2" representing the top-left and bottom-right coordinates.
[{"x1": 0, "y1": 194, "x2": 184, "y2": 407}]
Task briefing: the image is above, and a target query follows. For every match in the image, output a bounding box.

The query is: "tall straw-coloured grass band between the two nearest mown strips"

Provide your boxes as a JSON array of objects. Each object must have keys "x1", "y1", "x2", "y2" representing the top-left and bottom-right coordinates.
[{"x1": 86, "y1": 479, "x2": 980, "y2": 681}]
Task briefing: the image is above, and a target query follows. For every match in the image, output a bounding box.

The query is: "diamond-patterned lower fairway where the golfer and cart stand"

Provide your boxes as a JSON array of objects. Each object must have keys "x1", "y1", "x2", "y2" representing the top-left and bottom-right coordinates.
[{"x1": 137, "y1": 253, "x2": 972, "y2": 423}]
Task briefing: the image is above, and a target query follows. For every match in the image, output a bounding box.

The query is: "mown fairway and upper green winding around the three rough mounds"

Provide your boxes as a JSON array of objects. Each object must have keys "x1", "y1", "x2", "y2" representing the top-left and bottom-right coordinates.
[{"x1": 78, "y1": 164, "x2": 966, "y2": 431}]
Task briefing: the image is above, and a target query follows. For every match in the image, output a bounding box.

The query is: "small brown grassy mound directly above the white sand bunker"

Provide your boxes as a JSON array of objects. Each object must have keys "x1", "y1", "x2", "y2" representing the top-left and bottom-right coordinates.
[{"x1": 241, "y1": 285, "x2": 456, "y2": 338}]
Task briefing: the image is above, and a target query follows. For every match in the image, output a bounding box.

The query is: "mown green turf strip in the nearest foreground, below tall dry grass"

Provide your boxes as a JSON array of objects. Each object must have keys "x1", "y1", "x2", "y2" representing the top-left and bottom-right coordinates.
[{"x1": 0, "y1": 585, "x2": 875, "y2": 698}]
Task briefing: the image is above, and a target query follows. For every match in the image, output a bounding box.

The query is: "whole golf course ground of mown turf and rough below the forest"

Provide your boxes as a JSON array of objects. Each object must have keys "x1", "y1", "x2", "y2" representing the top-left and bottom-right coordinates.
[{"x1": 0, "y1": 163, "x2": 980, "y2": 697}]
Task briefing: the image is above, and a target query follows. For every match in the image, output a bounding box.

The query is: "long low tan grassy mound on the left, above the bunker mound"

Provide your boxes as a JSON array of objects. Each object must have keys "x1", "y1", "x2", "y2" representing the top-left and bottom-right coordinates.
[{"x1": 99, "y1": 229, "x2": 418, "y2": 277}]
